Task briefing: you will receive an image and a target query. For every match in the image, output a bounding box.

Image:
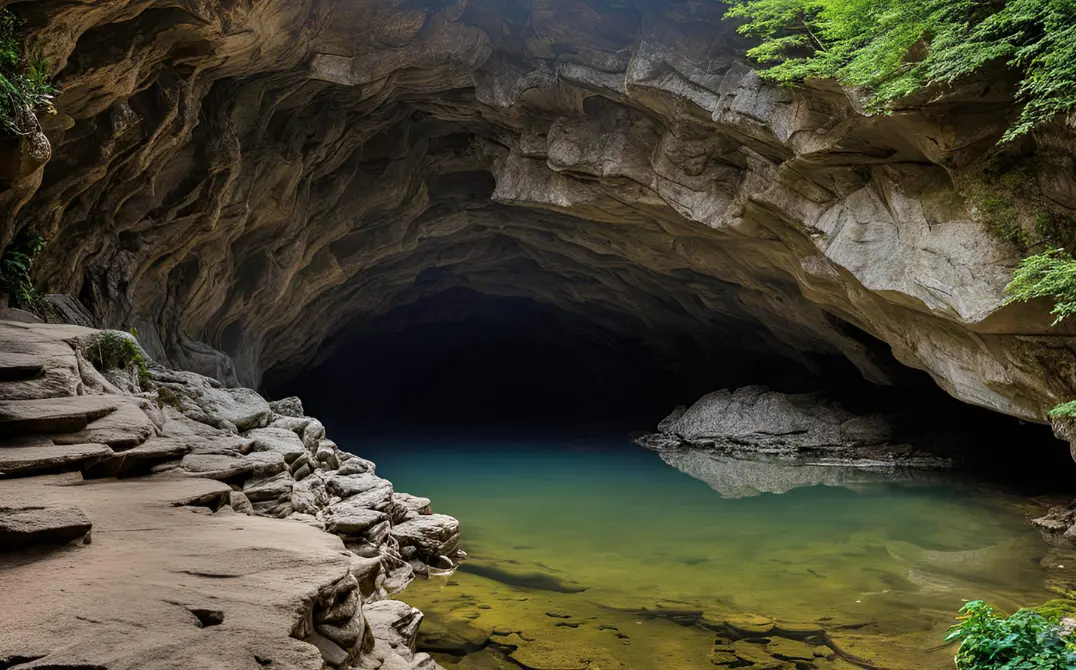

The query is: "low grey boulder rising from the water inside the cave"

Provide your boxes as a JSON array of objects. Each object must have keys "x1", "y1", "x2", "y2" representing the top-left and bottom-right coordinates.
[{"x1": 636, "y1": 386, "x2": 959, "y2": 469}]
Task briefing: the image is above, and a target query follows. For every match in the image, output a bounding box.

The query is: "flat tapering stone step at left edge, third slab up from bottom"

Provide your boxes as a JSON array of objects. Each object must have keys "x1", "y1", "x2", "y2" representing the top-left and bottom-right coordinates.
[{"x1": 0, "y1": 396, "x2": 122, "y2": 443}]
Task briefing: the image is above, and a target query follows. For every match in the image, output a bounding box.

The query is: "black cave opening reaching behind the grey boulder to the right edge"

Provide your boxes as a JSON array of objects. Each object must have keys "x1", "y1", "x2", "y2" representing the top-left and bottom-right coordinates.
[{"x1": 265, "y1": 288, "x2": 1073, "y2": 491}]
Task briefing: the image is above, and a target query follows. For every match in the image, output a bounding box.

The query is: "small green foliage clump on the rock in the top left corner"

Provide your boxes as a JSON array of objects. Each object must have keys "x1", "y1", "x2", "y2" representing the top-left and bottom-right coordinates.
[{"x1": 0, "y1": 10, "x2": 56, "y2": 134}]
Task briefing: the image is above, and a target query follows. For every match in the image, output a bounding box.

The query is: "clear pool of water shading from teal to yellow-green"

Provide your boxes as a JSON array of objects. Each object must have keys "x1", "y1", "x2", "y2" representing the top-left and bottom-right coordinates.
[{"x1": 363, "y1": 441, "x2": 1076, "y2": 669}]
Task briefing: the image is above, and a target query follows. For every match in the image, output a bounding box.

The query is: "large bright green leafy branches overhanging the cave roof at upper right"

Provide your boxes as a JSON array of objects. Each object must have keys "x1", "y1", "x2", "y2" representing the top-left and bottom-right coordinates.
[{"x1": 727, "y1": 0, "x2": 1076, "y2": 140}]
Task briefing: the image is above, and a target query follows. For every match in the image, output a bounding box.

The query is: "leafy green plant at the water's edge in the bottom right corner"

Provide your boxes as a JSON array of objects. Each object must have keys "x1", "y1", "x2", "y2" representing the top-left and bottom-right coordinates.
[{"x1": 946, "y1": 600, "x2": 1076, "y2": 670}]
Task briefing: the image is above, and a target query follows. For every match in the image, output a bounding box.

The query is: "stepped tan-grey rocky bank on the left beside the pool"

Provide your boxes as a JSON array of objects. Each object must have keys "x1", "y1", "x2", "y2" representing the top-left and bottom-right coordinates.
[{"x1": 0, "y1": 320, "x2": 463, "y2": 670}]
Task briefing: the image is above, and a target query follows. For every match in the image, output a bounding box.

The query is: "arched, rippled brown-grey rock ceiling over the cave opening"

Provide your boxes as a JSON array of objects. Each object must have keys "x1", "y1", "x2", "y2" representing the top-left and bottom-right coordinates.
[{"x1": 6, "y1": 0, "x2": 1076, "y2": 420}]
